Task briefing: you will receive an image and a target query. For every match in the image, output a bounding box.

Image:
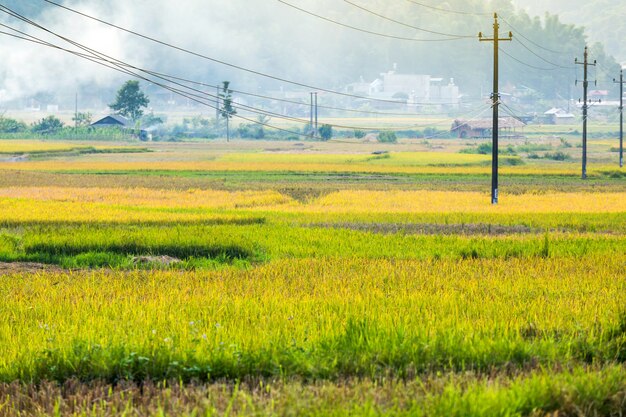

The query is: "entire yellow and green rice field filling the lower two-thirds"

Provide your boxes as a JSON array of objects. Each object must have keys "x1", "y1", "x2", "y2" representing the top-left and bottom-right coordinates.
[{"x1": 0, "y1": 138, "x2": 626, "y2": 416}]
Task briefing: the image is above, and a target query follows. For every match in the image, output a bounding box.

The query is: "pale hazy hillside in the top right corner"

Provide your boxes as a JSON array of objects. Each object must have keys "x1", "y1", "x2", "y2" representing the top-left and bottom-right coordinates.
[{"x1": 514, "y1": 0, "x2": 626, "y2": 63}]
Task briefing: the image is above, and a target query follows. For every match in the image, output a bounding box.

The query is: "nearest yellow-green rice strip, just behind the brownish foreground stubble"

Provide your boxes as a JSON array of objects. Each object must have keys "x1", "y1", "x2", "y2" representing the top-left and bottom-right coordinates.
[{"x1": 0, "y1": 254, "x2": 626, "y2": 382}]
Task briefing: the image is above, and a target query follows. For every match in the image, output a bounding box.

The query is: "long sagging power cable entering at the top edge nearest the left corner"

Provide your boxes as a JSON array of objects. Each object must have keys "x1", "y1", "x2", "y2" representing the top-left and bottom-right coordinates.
[{"x1": 41, "y1": 0, "x2": 454, "y2": 103}]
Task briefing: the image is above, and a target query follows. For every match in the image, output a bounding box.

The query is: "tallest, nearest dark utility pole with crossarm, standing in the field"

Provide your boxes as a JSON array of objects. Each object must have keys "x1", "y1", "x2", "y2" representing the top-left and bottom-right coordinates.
[{"x1": 478, "y1": 13, "x2": 513, "y2": 204}]
